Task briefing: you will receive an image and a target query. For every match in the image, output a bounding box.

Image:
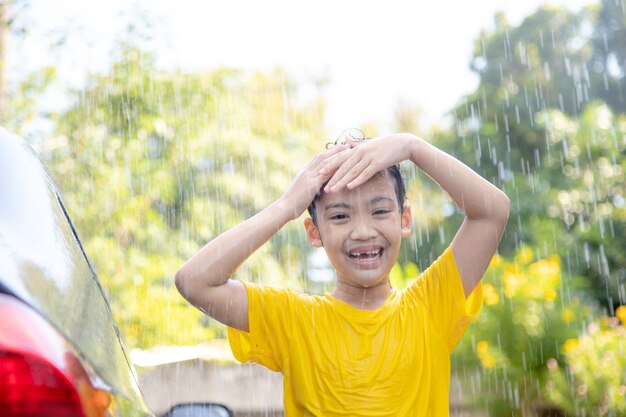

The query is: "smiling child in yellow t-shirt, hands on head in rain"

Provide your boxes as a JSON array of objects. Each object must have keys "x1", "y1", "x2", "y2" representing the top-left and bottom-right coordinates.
[{"x1": 176, "y1": 133, "x2": 509, "y2": 417}]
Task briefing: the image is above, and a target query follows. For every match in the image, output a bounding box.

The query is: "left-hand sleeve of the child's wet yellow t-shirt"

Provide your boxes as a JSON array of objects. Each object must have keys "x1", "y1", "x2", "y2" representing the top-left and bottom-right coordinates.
[{"x1": 228, "y1": 281, "x2": 290, "y2": 372}]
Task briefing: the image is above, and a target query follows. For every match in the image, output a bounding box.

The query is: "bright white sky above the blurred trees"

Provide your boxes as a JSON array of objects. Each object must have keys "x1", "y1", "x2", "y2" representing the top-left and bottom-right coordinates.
[{"x1": 14, "y1": 0, "x2": 590, "y2": 134}]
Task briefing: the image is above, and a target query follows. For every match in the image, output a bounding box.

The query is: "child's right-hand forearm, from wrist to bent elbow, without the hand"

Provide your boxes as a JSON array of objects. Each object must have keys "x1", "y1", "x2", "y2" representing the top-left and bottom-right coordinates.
[{"x1": 407, "y1": 135, "x2": 509, "y2": 223}]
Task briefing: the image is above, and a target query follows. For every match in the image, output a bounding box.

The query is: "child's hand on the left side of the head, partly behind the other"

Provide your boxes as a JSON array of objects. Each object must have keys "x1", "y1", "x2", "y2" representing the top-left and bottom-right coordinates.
[{"x1": 278, "y1": 144, "x2": 350, "y2": 220}]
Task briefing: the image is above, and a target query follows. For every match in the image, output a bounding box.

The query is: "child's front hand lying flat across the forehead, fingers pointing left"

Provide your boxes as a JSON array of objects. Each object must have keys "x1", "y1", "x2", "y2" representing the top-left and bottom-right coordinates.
[{"x1": 320, "y1": 133, "x2": 414, "y2": 192}]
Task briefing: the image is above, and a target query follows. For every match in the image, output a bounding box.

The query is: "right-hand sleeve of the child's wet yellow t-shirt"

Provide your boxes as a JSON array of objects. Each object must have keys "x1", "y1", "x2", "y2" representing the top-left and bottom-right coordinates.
[{"x1": 408, "y1": 246, "x2": 483, "y2": 352}]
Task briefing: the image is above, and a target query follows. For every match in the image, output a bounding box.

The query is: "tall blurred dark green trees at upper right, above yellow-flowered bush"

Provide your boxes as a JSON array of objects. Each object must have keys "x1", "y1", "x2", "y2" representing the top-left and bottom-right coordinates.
[{"x1": 435, "y1": 1, "x2": 626, "y2": 316}]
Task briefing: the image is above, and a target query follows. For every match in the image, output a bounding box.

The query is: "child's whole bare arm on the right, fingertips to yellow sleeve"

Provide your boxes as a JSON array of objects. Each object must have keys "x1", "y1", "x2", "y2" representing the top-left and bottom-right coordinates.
[{"x1": 322, "y1": 133, "x2": 510, "y2": 296}]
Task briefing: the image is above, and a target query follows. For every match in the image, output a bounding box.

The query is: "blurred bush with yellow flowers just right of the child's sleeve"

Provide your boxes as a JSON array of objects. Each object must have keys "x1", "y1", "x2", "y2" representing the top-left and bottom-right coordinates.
[{"x1": 453, "y1": 246, "x2": 597, "y2": 416}]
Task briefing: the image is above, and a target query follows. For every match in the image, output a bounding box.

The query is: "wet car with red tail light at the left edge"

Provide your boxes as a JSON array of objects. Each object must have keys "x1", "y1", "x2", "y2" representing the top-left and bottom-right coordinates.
[{"x1": 0, "y1": 128, "x2": 232, "y2": 417}]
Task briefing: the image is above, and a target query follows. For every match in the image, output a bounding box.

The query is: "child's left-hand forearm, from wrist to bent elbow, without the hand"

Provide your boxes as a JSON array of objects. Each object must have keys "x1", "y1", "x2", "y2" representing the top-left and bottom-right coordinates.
[{"x1": 176, "y1": 200, "x2": 290, "y2": 295}]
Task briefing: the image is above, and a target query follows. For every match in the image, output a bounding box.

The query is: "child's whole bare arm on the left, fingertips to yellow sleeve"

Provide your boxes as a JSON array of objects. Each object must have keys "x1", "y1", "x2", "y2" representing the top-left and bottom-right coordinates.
[{"x1": 176, "y1": 146, "x2": 348, "y2": 331}]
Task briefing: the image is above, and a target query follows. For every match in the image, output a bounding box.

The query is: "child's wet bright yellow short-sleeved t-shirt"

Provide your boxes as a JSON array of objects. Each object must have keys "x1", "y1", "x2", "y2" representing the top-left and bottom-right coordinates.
[{"x1": 228, "y1": 247, "x2": 482, "y2": 417}]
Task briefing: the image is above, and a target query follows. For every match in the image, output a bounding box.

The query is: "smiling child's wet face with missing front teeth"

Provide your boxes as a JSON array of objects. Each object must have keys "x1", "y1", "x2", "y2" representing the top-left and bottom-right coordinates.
[{"x1": 307, "y1": 173, "x2": 412, "y2": 288}]
